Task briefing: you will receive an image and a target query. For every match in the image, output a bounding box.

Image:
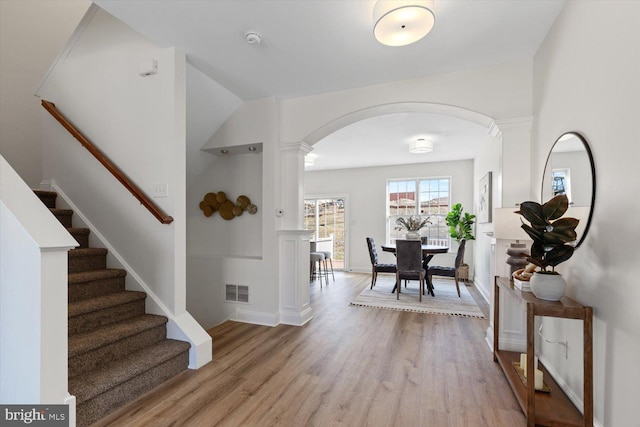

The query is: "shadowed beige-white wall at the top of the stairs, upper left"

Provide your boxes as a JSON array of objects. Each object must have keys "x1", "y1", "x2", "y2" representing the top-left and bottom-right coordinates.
[{"x1": 0, "y1": 0, "x2": 91, "y2": 188}]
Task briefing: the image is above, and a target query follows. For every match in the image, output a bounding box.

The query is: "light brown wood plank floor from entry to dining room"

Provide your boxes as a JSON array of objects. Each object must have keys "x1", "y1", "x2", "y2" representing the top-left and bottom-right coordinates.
[{"x1": 95, "y1": 273, "x2": 526, "y2": 427}]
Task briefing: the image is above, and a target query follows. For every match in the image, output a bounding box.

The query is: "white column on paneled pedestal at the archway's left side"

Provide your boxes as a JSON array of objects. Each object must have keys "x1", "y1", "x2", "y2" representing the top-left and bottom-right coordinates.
[{"x1": 278, "y1": 142, "x2": 312, "y2": 326}]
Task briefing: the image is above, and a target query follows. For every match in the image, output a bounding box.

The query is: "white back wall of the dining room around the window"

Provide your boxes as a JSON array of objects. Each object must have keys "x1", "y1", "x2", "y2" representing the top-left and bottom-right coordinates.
[{"x1": 305, "y1": 160, "x2": 475, "y2": 272}]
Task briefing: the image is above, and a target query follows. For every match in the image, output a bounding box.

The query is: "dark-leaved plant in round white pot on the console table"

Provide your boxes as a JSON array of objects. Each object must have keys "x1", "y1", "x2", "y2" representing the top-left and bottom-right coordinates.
[{"x1": 516, "y1": 194, "x2": 579, "y2": 301}]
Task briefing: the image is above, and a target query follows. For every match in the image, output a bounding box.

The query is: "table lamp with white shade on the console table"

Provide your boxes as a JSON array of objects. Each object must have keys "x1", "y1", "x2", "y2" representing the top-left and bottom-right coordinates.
[{"x1": 493, "y1": 207, "x2": 531, "y2": 275}]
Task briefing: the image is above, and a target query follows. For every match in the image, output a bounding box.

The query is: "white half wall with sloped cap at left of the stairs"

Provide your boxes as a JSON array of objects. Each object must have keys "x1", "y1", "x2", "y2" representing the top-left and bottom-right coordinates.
[{"x1": 0, "y1": 156, "x2": 77, "y2": 406}]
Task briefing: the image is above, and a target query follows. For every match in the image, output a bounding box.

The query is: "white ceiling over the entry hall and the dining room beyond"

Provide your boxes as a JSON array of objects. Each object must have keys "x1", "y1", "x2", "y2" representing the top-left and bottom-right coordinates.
[{"x1": 95, "y1": 0, "x2": 565, "y2": 169}]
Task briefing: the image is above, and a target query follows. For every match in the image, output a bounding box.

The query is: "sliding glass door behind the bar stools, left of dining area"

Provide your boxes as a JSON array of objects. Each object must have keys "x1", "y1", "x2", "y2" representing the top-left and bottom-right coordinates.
[{"x1": 304, "y1": 197, "x2": 347, "y2": 270}]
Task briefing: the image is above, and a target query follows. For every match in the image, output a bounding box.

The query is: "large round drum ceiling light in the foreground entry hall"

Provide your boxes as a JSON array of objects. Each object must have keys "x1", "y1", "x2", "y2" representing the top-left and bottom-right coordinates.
[{"x1": 373, "y1": 0, "x2": 435, "y2": 46}]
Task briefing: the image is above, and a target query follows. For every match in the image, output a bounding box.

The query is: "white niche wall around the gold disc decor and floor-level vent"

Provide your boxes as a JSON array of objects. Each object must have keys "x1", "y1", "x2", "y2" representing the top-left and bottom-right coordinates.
[{"x1": 187, "y1": 98, "x2": 279, "y2": 328}]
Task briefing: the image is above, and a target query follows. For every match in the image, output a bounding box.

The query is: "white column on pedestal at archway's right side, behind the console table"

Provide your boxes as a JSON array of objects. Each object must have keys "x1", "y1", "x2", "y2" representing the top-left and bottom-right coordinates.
[{"x1": 487, "y1": 117, "x2": 539, "y2": 351}]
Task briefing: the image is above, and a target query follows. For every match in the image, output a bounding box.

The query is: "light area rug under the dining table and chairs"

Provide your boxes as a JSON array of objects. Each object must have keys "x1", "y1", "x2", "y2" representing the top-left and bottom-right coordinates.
[{"x1": 351, "y1": 277, "x2": 485, "y2": 319}]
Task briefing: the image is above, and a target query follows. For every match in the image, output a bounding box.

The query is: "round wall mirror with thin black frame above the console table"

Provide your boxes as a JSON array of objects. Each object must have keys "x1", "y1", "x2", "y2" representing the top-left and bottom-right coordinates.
[{"x1": 540, "y1": 132, "x2": 596, "y2": 247}]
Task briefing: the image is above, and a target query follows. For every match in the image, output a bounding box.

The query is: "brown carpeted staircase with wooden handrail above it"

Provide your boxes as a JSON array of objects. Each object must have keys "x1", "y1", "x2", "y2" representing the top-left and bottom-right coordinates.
[{"x1": 35, "y1": 190, "x2": 190, "y2": 427}]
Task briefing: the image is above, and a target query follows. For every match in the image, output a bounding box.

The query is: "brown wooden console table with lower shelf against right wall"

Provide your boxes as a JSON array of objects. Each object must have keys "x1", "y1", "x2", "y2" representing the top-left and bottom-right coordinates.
[{"x1": 493, "y1": 277, "x2": 593, "y2": 427}]
